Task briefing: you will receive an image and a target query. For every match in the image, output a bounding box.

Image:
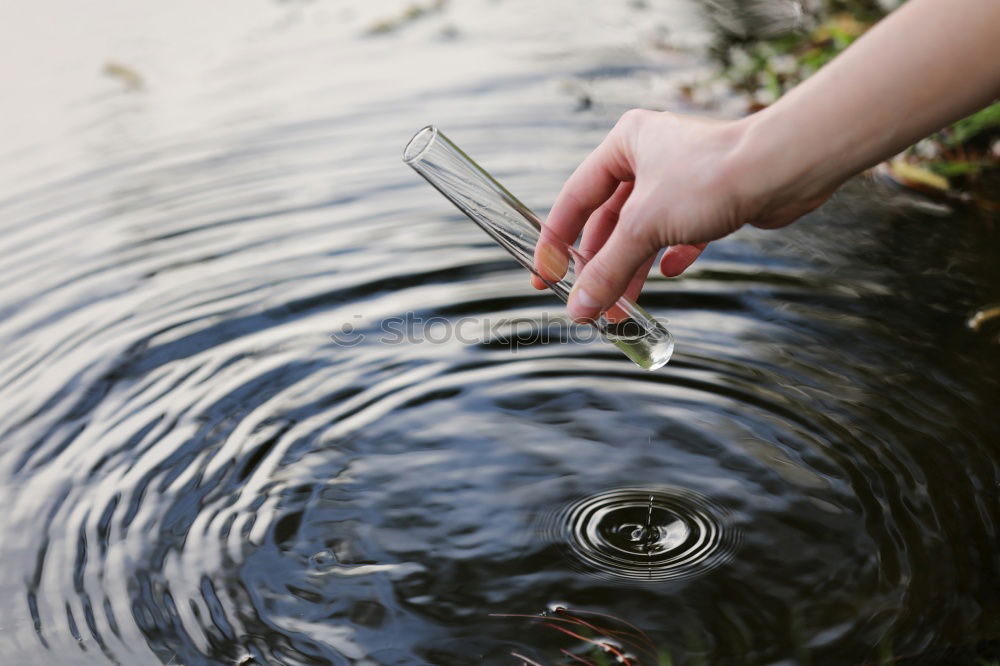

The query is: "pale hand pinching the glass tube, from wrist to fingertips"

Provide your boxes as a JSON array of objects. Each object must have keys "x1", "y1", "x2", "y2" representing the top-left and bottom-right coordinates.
[{"x1": 532, "y1": 110, "x2": 833, "y2": 320}]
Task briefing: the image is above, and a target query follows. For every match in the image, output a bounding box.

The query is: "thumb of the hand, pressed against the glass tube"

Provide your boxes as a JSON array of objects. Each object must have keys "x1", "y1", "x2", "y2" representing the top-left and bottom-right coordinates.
[{"x1": 569, "y1": 204, "x2": 658, "y2": 321}]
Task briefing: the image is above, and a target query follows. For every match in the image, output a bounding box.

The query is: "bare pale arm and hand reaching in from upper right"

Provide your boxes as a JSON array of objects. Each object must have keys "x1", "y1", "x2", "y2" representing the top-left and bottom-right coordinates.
[{"x1": 533, "y1": 0, "x2": 1000, "y2": 321}]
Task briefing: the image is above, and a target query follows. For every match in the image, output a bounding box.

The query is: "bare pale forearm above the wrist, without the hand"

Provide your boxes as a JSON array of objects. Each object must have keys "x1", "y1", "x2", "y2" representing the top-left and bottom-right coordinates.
[{"x1": 742, "y1": 0, "x2": 1000, "y2": 210}]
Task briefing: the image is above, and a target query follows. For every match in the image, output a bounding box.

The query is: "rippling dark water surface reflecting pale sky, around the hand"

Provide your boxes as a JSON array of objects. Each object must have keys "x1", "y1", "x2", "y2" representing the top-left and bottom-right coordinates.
[{"x1": 0, "y1": 2, "x2": 1000, "y2": 665}]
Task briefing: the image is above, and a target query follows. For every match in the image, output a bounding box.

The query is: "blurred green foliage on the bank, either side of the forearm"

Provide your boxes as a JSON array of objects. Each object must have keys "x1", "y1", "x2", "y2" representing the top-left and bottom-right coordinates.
[{"x1": 714, "y1": 0, "x2": 1000, "y2": 211}]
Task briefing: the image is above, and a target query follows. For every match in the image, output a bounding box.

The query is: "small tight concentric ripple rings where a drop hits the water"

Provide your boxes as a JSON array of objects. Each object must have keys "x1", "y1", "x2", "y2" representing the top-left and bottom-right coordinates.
[{"x1": 558, "y1": 487, "x2": 738, "y2": 580}]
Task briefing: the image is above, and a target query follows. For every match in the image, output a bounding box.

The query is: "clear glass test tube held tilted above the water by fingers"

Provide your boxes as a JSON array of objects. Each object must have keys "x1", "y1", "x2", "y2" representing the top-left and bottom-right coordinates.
[{"x1": 403, "y1": 125, "x2": 674, "y2": 370}]
